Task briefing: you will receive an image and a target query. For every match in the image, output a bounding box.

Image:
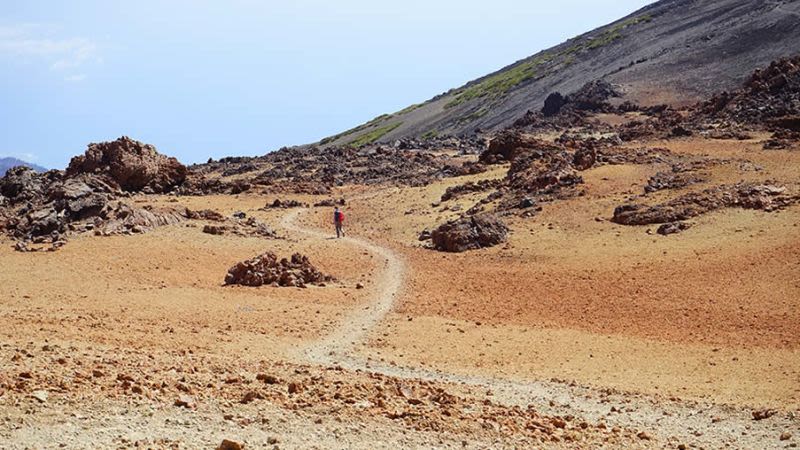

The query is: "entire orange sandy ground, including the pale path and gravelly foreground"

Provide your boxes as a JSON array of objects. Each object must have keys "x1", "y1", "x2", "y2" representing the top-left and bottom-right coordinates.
[{"x1": 0, "y1": 137, "x2": 800, "y2": 448}]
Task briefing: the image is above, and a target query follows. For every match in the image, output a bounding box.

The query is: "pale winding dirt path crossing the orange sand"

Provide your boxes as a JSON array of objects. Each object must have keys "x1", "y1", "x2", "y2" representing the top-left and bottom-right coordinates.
[{"x1": 281, "y1": 209, "x2": 800, "y2": 449}]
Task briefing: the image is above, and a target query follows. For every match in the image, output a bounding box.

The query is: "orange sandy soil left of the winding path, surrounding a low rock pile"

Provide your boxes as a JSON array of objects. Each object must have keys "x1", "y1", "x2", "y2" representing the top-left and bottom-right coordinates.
[{"x1": 0, "y1": 192, "x2": 373, "y2": 358}]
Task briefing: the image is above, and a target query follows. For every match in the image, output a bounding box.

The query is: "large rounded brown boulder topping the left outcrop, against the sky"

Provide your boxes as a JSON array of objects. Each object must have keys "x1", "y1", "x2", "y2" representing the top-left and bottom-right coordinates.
[{"x1": 67, "y1": 136, "x2": 187, "y2": 193}]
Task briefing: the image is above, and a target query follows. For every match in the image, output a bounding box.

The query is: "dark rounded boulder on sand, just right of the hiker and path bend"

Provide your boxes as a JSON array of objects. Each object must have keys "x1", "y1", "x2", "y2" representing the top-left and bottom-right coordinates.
[{"x1": 431, "y1": 214, "x2": 508, "y2": 253}]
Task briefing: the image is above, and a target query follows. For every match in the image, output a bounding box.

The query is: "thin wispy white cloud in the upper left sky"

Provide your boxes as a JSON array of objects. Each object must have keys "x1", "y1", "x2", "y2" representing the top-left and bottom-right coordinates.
[{"x1": 0, "y1": 24, "x2": 101, "y2": 77}]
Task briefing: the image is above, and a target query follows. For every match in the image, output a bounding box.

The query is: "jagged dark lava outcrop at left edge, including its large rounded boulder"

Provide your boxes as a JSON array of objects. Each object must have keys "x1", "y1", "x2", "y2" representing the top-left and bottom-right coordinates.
[{"x1": 0, "y1": 137, "x2": 188, "y2": 251}]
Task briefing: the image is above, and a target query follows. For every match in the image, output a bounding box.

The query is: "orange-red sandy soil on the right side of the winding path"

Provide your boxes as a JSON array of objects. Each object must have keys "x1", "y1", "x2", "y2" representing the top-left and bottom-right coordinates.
[{"x1": 328, "y1": 134, "x2": 800, "y2": 409}]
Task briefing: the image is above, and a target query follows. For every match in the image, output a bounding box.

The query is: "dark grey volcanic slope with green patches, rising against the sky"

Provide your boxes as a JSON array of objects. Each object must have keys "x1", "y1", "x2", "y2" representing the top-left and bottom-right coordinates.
[{"x1": 320, "y1": 0, "x2": 800, "y2": 145}]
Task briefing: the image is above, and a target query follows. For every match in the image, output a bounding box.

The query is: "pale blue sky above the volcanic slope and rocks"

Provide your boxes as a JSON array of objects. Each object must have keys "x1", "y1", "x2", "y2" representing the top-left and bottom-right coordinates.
[{"x1": 0, "y1": 0, "x2": 651, "y2": 168}]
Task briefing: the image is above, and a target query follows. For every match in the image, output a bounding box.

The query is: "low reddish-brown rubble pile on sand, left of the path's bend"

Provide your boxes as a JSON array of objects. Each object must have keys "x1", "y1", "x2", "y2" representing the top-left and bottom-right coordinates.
[{"x1": 225, "y1": 252, "x2": 335, "y2": 287}]
